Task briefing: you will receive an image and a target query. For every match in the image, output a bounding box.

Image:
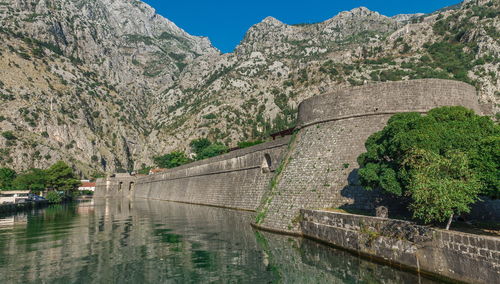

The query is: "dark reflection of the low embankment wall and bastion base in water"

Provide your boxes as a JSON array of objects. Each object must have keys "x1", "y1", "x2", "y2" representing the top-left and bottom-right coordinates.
[{"x1": 256, "y1": 232, "x2": 436, "y2": 284}]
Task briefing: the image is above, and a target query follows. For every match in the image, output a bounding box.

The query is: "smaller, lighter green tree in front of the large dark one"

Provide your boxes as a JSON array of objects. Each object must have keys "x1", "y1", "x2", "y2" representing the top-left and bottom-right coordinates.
[{"x1": 404, "y1": 150, "x2": 480, "y2": 230}]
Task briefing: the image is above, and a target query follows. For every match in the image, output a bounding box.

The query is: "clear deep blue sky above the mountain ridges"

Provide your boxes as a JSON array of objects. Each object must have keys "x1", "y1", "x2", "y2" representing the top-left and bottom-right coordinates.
[{"x1": 145, "y1": 0, "x2": 461, "y2": 52}]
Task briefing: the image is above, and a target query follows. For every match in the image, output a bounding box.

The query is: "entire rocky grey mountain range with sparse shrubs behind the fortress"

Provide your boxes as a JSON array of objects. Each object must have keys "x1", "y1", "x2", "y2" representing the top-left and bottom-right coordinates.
[{"x1": 0, "y1": 0, "x2": 500, "y2": 176}]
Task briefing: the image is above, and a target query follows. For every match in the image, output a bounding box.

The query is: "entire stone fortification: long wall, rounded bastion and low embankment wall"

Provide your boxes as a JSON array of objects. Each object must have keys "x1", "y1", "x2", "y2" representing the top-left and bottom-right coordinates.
[{"x1": 95, "y1": 79, "x2": 500, "y2": 283}]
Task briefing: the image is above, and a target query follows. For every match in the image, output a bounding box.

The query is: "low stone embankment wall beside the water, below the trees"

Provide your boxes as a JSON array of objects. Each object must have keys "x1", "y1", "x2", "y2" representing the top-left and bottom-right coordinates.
[{"x1": 300, "y1": 209, "x2": 500, "y2": 283}]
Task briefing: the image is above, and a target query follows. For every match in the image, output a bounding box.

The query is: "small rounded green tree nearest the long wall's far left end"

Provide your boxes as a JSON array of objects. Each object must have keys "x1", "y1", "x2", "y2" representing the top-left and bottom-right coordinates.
[{"x1": 46, "y1": 161, "x2": 81, "y2": 195}]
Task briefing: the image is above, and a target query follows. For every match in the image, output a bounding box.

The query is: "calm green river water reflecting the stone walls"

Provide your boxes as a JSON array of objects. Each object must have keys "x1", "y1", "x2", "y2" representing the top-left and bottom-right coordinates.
[{"x1": 0, "y1": 199, "x2": 446, "y2": 284}]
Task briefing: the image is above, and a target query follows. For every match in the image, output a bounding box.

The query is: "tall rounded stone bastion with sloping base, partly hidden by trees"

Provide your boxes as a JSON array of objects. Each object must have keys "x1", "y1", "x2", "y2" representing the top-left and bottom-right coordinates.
[{"x1": 256, "y1": 79, "x2": 480, "y2": 233}]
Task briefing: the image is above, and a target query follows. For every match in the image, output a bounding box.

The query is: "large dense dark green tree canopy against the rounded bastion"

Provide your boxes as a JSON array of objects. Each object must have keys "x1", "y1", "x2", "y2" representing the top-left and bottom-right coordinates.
[{"x1": 358, "y1": 107, "x2": 500, "y2": 224}]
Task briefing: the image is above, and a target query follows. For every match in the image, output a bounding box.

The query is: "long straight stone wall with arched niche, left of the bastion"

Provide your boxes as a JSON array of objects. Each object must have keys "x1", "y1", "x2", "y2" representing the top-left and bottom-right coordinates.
[{"x1": 96, "y1": 137, "x2": 289, "y2": 211}]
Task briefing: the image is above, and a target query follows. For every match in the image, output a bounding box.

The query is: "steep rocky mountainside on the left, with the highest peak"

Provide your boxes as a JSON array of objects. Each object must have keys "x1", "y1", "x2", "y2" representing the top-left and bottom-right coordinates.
[{"x1": 0, "y1": 0, "x2": 219, "y2": 175}]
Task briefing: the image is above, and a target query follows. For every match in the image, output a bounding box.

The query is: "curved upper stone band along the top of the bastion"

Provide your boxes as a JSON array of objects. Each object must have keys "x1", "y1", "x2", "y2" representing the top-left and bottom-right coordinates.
[{"x1": 297, "y1": 79, "x2": 481, "y2": 127}]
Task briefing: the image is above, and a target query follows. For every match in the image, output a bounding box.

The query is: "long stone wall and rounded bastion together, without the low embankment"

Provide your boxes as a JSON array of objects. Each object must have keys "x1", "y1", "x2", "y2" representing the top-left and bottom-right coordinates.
[{"x1": 96, "y1": 79, "x2": 480, "y2": 222}]
